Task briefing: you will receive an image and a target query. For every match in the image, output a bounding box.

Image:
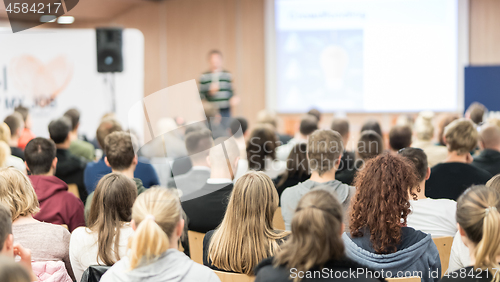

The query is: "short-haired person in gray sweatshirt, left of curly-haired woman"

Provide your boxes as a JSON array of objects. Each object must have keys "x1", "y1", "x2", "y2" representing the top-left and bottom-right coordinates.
[{"x1": 281, "y1": 129, "x2": 355, "y2": 230}]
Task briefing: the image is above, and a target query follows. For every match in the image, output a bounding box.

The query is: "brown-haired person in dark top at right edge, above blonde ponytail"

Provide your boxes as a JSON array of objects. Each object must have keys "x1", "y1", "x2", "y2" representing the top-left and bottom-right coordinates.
[{"x1": 472, "y1": 124, "x2": 500, "y2": 175}]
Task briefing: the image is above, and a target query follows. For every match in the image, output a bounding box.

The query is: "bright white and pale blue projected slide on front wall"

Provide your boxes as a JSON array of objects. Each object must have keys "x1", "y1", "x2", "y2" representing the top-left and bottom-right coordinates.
[{"x1": 275, "y1": 0, "x2": 458, "y2": 113}]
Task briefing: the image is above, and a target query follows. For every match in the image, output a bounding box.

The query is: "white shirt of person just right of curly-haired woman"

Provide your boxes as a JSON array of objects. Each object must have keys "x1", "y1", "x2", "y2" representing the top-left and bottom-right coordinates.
[{"x1": 407, "y1": 198, "x2": 457, "y2": 238}]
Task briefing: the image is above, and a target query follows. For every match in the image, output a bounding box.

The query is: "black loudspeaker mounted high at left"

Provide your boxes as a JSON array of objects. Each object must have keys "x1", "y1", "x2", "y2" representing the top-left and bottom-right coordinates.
[{"x1": 96, "y1": 28, "x2": 123, "y2": 72}]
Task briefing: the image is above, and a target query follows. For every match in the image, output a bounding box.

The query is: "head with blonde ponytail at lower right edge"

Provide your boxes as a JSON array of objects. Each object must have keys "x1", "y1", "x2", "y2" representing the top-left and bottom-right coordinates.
[{"x1": 457, "y1": 185, "x2": 500, "y2": 282}]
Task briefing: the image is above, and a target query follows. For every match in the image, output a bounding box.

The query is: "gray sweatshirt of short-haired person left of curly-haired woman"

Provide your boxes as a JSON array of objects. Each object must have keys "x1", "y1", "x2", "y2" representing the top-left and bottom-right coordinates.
[{"x1": 281, "y1": 179, "x2": 356, "y2": 231}]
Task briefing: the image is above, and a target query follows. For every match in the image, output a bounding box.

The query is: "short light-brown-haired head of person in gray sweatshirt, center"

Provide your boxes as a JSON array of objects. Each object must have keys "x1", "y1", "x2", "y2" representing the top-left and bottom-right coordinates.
[{"x1": 307, "y1": 129, "x2": 344, "y2": 177}]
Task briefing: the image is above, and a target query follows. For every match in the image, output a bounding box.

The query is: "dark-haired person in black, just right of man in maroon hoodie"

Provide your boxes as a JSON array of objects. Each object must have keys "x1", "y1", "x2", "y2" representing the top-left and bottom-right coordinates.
[{"x1": 49, "y1": 117, "x2": 88, "y2": 203}]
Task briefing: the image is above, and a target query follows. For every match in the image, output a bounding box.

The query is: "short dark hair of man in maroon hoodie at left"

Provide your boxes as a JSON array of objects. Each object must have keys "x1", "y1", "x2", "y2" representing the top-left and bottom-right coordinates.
[{"x1": 24, "y1": 137, "x2": 56, "y2": 175}]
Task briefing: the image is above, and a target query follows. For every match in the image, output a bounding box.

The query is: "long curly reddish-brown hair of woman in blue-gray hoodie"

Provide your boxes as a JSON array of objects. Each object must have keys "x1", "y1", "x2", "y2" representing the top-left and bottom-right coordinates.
[{"x1": 349, "y1": 153, "x2": 418, "y2": 254}]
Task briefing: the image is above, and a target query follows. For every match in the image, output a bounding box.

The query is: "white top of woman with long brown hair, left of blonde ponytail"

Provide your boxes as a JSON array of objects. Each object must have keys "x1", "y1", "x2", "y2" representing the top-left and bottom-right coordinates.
[{"x1": 69, "y1": 223, "x2": 134, "y2": 281}]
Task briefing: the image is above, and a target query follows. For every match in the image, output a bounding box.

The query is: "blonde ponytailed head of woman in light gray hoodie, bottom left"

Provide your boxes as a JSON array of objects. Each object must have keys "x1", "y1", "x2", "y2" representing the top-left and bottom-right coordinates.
[{"x1": 129, "y1": 188, "x2": 184, "y2": 269}]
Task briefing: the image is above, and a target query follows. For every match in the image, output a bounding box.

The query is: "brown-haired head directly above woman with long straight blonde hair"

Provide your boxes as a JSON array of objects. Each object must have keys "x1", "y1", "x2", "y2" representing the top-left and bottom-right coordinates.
[{"x1": 247, "y1": 124, "x2": 278, "y2": 171}]
